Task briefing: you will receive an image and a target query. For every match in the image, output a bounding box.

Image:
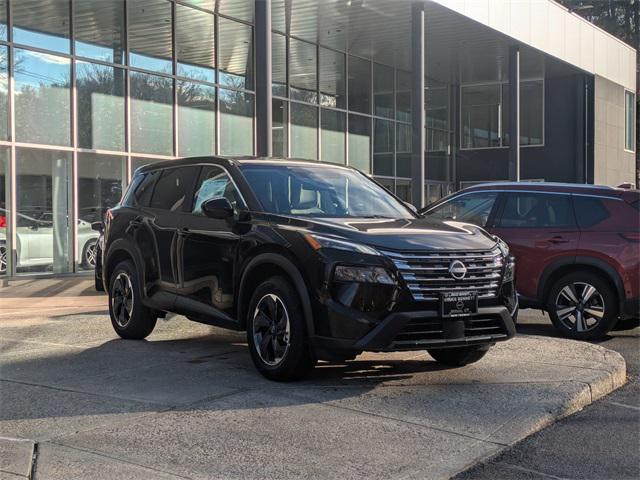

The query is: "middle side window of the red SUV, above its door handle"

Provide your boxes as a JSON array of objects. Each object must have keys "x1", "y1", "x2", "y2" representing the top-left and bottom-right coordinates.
[{"x1": 500, "y1": 193, "x2": 575, "y2": 228}]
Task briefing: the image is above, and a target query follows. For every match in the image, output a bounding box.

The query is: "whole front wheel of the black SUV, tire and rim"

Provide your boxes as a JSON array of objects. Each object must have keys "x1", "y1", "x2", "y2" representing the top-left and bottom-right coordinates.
[{"x1": 246, "y1": 276, "x2": 316, "y2": 382}]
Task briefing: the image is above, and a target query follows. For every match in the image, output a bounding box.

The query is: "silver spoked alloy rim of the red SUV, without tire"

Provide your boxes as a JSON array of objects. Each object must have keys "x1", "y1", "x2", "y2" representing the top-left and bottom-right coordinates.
[{"x1": 555, "y1": 282, "x2": 605, "y2": 332}]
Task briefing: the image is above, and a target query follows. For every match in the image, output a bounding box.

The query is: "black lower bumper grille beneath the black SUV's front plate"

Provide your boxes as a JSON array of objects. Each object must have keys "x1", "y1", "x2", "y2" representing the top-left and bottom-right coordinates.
[{"x1": 389, "y1": 316, "x2": 507, "y2": 350}]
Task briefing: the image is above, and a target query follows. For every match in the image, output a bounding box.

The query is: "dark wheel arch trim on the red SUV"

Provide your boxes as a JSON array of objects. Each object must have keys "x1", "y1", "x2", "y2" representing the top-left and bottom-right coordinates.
[{"x1": 538, "y1": 256, "x2": 625, "y2": 311}]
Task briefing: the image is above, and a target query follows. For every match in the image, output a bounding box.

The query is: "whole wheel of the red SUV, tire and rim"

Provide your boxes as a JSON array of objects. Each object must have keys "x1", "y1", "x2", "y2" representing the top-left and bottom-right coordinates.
[{"x1": 546, "y1": 271, "x2": 618, "y2": 340}]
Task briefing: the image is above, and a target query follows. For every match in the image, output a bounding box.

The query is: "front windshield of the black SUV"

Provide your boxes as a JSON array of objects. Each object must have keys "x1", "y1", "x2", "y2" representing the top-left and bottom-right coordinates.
[{"x1": 240, "y1": 164, "x2": 414, "y2": 218}]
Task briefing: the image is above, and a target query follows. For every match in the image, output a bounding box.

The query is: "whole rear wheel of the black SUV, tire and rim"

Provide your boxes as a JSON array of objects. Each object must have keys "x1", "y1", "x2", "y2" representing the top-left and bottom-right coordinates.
[{"x1": 109, "y1": 260, "x2": 157, "y2": 340}]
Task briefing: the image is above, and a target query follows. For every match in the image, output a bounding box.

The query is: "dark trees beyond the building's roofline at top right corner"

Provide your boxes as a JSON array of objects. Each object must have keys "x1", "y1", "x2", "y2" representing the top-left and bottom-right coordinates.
[{"x1": 557, "y1": 0, "x2": 640, "y2": 188}]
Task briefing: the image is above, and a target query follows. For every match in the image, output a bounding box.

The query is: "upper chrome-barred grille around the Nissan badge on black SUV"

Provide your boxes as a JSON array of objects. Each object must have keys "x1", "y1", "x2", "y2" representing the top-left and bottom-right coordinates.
[{"x1": 383, "y1": 249, "x2": 503, "y2": 301}]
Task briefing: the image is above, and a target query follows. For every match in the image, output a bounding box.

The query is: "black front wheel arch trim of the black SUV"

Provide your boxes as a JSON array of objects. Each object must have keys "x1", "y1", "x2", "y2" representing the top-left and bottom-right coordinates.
[{"x1": 236, "y1": 251, "x2": 314, "y2": 335}]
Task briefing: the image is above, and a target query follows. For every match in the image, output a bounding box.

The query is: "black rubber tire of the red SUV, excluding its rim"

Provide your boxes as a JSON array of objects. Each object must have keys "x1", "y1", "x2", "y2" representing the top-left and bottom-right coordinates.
[{"x1": 546, "y1": 272, "x2": 618, "y2": 340}]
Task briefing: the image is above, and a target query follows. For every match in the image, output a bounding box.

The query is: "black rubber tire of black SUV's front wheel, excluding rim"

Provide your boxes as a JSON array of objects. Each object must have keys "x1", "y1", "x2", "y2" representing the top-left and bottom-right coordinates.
[{"x1": 246, "y1": 276, "x2": 315, "y2": 381}]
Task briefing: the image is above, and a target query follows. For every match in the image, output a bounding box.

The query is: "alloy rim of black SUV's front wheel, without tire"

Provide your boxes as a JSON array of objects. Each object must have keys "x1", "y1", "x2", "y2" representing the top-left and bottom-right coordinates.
[{"x1": 253, "y1": 293, "x2": 291, "y2": 366}]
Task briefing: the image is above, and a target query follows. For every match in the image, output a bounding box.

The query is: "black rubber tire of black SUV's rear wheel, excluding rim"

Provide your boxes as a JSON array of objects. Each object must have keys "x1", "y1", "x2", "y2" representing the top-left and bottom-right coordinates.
[{"x1": 109, "y1": 260, "x2": 157, "y2": 340}]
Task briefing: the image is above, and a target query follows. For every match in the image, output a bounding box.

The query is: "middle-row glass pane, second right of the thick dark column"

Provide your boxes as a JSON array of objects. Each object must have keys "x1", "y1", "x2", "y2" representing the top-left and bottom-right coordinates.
[{"x1": 289, "y1": 38, "x2": 318, "y2": 103}]
